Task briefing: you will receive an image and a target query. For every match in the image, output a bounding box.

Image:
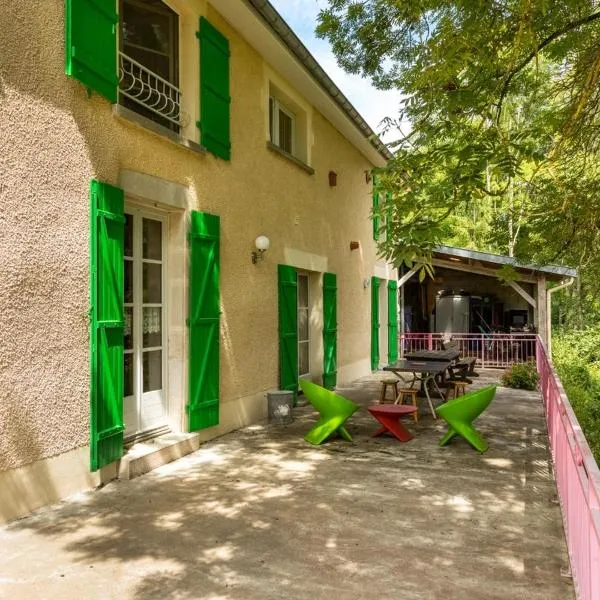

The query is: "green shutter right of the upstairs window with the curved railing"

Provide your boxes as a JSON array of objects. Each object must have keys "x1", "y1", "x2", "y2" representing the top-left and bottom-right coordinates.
[{"x1": 196, "y1": 17, "x2": 231, "y2": 160}]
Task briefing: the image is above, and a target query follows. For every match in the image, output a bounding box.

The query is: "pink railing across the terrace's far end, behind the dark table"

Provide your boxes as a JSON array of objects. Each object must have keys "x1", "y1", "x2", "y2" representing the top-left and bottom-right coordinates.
[{"x1": 400, "y1": 333, "x2": 537, "y2": 369}]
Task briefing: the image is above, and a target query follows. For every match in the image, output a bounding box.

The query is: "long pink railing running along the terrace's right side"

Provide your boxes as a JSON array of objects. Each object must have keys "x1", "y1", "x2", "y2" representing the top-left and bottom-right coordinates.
[{"x1": 536, "y1": 338, "x2": 600, "y2": 600}]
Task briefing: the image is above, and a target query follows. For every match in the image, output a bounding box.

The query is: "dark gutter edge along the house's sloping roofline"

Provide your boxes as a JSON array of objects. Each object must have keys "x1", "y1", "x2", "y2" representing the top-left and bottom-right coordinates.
[{"x1": 244, "y1": 0, "x2": 393, "y2": 161}]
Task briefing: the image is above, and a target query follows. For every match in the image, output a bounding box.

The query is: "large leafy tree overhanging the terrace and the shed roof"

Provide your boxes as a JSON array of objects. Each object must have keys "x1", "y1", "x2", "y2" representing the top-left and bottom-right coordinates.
[{"x1": 317, "y1": 0, "x2": 600, "y2": 326}]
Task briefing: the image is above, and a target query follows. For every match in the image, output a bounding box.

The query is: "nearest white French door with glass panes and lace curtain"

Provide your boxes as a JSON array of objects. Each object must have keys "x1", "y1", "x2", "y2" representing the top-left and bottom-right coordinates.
[{"x1": 123, "y1": 209, "x2": 167, "y2": 437}]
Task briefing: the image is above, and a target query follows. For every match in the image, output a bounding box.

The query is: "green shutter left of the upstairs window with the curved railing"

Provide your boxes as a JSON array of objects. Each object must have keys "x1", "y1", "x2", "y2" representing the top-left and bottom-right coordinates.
[{"x1": 65, "y1": 0, "x2": 119, "y2": 103}]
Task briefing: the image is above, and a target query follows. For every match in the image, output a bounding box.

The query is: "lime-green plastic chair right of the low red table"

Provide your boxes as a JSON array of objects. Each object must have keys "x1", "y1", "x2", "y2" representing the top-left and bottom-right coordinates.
[{"x1": 435, "y1": 385, "x2": 496, "y2": 452}]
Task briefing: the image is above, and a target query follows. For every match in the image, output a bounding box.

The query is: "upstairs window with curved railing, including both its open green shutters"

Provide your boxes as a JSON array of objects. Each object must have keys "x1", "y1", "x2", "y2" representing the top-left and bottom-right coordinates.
[{"x1": 65, "y1": 0, "x2": 231, "y2": 160}]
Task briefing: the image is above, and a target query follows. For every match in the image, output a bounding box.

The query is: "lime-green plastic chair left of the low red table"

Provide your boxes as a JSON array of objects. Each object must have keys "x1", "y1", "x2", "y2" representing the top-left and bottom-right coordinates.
[{"x1": 300, "y1": 379, "x2": 360, "y2": 446}]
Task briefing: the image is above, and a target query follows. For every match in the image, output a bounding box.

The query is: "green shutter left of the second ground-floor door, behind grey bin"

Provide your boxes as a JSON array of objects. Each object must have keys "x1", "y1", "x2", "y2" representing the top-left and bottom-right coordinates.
[{"x1": 277, "y1": 265, "x2": 298, "y2": 402}]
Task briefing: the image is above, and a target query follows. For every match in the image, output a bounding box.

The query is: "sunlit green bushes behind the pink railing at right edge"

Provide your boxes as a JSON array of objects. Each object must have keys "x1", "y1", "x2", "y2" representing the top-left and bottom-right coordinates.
[{"x1": 552, "y1": 326, "x2": 600, "y2": 463}]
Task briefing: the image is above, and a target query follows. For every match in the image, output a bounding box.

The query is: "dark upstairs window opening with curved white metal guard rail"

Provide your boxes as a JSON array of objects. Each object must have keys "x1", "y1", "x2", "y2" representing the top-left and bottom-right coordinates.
[{"x1": 119, "y1": 0, "x2": 181, "y2": 131}]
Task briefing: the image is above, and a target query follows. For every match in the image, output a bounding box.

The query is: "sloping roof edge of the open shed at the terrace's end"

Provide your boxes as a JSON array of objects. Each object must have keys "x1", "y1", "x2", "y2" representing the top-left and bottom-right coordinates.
[{"x1": 433, "y1": 246, "x2": 577, "y2": 281}]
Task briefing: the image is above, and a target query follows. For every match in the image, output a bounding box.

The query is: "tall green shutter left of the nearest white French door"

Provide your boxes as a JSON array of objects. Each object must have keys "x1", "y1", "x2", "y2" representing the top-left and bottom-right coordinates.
[{"x1": 90, "y1": 180, "x2": 125, "y2": 471}]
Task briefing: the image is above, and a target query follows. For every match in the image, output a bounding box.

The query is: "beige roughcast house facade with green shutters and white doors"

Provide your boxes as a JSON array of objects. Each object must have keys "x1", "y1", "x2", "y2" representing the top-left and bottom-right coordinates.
[{"x1": 0, "y1": 0, "x2": 398, "y2": 520}]
